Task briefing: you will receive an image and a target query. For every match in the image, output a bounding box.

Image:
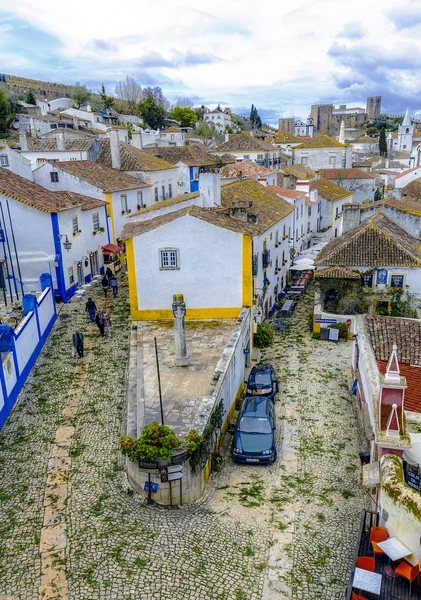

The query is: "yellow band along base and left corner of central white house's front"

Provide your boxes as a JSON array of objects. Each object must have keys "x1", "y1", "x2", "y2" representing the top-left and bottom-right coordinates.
[{"x1": 127, "y1": 308, "x2": 241, "y2": 321}]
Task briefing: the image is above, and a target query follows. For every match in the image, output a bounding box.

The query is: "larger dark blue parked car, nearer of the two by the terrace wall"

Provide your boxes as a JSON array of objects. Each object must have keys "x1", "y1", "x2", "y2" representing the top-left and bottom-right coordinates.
[{"x1": 232, "y1": 396, "x2": 276, "y2": 464}]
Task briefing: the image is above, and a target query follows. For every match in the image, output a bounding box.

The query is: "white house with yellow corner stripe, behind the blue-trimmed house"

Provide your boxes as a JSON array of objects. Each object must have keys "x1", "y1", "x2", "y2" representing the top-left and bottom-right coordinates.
[{"x1": 33, "y1": 160, "x2": 150, "y2": 244}]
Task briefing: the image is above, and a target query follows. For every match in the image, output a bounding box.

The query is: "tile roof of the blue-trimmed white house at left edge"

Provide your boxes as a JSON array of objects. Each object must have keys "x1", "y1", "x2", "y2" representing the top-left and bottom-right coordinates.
[{"x1": 0, "y1": 169, "x2": 102, "y2": 212}]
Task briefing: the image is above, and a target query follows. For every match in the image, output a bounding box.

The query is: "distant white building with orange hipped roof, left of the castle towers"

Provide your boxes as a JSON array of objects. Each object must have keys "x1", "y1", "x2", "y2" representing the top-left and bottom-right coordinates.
[{"x1": 292, "y1": 135, "x2": 352, "y2": 170}]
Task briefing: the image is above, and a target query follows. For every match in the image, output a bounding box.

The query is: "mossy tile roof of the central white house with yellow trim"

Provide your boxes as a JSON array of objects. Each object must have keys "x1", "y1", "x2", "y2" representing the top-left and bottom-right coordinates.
[{"x1": 122, "y1": 179, "x2": 294, "y2": 239}]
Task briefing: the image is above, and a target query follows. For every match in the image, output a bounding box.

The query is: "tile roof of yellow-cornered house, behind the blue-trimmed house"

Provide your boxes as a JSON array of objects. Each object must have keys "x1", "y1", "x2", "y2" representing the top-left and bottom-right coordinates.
[{"x1": 54, "y1": 160, "x2": 150, "y2": 193}]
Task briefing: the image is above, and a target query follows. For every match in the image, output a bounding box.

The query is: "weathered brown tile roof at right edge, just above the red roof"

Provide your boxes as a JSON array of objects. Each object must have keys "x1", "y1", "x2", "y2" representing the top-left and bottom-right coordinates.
[{"x1": 364, "y1": 315, "x2": 421, "y2": 367}]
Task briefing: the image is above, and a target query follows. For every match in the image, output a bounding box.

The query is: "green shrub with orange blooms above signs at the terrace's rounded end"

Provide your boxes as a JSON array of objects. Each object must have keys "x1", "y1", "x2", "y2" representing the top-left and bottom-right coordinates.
[{"x1": 119, "y1": 421, "x2": 181, "y2": 461}]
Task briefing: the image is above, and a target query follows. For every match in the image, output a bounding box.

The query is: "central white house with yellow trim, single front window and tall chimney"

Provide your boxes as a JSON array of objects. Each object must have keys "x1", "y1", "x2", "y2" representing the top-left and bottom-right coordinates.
[{"x1": 122, "y1": 175, "x2": 294, "y2": 320}]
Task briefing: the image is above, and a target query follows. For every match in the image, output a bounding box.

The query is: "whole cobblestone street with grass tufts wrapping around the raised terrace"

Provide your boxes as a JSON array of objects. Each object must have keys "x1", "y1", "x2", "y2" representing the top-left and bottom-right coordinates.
[{"x1": 0, "y1": 275, "x2": 364, "y2": 600}]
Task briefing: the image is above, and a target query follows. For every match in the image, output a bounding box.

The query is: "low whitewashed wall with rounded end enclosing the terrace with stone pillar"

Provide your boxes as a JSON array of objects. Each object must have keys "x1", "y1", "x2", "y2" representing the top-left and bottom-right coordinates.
[{"x1": 126, "y1": 309, "x2": 252, "y2": 505}]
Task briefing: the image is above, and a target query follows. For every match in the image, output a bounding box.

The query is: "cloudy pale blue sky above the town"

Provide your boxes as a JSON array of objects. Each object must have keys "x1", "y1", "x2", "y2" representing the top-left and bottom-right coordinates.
[{"x1": 0, "y1": 0, "x2": 421, "y2": 124}]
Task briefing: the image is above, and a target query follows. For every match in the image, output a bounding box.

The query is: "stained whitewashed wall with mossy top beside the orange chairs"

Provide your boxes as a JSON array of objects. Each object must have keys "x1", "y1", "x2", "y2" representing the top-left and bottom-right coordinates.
[{"x1": 379, "y1": 454, "x2": 421, "y2": 565}]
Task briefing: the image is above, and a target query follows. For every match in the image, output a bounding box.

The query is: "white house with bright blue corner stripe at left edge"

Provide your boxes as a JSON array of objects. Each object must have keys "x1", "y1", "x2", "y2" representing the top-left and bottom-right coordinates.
[{"x1": 0, "y1": 165, "x2": 109, "y2": 301}]
